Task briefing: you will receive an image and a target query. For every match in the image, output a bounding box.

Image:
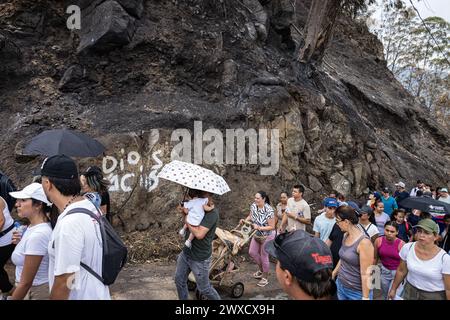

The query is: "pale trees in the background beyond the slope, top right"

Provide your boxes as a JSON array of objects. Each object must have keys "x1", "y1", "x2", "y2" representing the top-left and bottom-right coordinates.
[{"x1": 374, "y1": 6, "x2": 450, "y2": 126}]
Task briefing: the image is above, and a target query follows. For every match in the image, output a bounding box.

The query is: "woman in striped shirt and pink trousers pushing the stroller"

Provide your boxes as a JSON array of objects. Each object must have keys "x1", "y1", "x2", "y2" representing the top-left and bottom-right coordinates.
[{"x1": 240, "y1": 191, "x2": 275, "y2": 287}]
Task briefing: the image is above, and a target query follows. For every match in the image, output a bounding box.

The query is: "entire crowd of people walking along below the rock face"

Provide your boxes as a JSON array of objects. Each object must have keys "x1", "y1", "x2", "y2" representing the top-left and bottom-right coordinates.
[{"x1": 0, "y1": 155, "x2": 450, "y2": 300}]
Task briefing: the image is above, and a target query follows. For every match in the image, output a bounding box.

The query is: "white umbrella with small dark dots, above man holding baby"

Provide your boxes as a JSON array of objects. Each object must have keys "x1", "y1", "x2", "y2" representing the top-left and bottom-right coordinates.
[{"x1": 158, "y1": 160, "x2": 230, "y2": 195}]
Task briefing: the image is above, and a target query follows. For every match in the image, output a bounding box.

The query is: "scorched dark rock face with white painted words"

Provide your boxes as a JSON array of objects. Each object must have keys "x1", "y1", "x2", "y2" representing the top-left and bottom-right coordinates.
[{"x1": 0, "y1": 0, "x2": 450, "y2": 238}]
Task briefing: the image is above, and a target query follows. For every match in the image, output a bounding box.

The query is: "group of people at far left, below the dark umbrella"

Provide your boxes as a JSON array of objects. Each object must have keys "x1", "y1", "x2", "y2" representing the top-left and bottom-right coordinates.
[{"x1": 0, "y1": 155, "x2": 111, "y2": 300}]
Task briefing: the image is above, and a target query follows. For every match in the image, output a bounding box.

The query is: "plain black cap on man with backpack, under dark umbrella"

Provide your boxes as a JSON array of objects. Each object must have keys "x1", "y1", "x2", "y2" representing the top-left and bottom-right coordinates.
[{"x1": 35, "y1": 154, "x2": 78, "y2": 179}]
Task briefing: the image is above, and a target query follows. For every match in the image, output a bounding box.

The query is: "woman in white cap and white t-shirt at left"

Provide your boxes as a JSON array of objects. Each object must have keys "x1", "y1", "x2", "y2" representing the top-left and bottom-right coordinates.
[{"x1": 9, "y1": 183, "x2": 52, "y2": 300}]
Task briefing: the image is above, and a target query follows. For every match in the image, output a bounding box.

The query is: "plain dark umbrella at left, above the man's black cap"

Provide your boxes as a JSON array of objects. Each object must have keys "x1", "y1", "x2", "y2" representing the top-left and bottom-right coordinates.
[{"x1": 24, "y1": 129, "x2": 105, "y2": 157}]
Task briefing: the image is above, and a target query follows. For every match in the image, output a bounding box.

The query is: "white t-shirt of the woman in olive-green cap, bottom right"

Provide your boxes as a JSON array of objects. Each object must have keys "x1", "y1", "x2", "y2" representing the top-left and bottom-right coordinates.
[{"x1": 400, "y1": 242, "x2": 450, "y2": 292}]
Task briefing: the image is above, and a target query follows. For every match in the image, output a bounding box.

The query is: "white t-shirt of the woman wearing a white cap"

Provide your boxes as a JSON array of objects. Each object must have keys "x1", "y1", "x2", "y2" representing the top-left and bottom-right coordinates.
[{"x1": 11, "y1": 223, "x2": 52, "y2": 286}]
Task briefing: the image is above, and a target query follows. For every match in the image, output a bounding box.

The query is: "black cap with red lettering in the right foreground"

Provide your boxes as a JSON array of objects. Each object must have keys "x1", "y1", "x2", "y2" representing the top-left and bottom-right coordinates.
[{"x1": 265, "y1": 230, "x2": 333, "y2": 282}]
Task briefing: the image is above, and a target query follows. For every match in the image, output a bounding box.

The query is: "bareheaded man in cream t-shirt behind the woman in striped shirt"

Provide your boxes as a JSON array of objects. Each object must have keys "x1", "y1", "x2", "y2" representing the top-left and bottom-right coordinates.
[{"x1": 281, "y1": 185, "x2": 311, "y2": 232}]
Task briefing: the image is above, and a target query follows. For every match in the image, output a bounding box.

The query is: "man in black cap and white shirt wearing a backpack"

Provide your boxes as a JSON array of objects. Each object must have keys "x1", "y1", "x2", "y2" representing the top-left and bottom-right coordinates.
[{"x1": 40, "y1": 155, "x2": 111, "y2": 300}]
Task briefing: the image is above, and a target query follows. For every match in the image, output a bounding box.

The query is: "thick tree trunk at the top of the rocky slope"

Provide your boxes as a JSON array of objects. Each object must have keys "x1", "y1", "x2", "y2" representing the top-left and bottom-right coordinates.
[{"x1": 298, "y1": 0, "x2": 342, "y2": 63}]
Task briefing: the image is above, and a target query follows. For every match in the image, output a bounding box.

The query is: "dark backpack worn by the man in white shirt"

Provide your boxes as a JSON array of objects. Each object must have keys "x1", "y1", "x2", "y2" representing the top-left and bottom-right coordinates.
[{"x1": 67, "y1": 208, "x2": 128, "y2": 285}]
